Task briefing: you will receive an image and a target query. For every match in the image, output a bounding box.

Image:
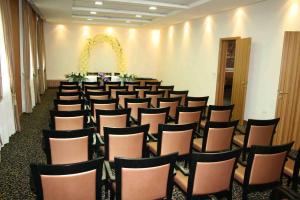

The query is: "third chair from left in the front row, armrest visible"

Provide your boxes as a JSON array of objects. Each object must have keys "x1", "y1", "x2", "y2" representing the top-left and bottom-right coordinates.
[{"x1": 174, "y1": 150, "x2": 241, "y2": 200}]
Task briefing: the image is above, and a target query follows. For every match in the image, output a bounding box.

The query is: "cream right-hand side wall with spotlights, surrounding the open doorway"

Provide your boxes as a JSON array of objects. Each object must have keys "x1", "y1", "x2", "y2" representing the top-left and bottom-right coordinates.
[{"x1": 158, "y1": 0, "x2": 300, "y2": 119}]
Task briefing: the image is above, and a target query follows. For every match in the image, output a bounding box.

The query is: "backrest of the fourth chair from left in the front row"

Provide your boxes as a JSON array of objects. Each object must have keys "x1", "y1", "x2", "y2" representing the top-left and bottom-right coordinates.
[{"x1": 244, "y1": 142, "x2": 293, "y2": 187}]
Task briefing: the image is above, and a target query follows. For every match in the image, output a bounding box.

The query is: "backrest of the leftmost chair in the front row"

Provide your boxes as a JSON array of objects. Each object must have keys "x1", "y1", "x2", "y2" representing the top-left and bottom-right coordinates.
[{"x1": 30, "y1": 158, "x2": 103, "y2": 200}]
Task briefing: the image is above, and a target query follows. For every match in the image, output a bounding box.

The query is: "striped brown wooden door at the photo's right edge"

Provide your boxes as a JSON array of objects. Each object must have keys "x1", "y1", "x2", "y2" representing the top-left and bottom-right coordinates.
[{"x1": 274, "y1": 32, "x2": 300, "y2": 148}]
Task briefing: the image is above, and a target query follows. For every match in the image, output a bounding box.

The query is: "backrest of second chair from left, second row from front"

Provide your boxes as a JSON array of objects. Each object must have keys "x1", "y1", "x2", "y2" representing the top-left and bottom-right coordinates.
[{"x1": 104, "y1": 125, "x2": 149, "y2": 162}]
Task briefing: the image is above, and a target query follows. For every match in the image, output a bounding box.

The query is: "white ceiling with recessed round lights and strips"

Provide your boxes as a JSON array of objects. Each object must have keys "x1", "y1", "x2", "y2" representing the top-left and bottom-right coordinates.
[{"x1": 29, "y1": 0, "x2": 264, "y2": 27}]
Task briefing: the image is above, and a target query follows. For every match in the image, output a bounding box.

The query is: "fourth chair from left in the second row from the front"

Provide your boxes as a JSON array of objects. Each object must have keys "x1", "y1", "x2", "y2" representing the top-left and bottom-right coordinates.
[{"x1": 193, "y1": 121, "x2": 238, "y2": 152}]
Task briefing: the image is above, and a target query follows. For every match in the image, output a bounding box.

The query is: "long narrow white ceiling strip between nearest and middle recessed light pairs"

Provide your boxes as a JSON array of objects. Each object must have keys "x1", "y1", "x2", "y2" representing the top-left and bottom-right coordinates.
[{"x1": 72, "y1": 6, "x2": 167, "y2": 17}]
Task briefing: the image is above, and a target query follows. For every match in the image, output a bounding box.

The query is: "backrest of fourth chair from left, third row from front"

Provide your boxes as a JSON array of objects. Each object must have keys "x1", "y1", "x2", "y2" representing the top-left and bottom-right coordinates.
[{"x1": 175, "y1": 106, "x2": 206, "y2": 124}]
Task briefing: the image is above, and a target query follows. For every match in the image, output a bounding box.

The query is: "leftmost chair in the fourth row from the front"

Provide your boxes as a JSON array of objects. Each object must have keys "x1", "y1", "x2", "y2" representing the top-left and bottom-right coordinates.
[{"x1": 54, "y1": 99, "x2": 85, "y2": 111}]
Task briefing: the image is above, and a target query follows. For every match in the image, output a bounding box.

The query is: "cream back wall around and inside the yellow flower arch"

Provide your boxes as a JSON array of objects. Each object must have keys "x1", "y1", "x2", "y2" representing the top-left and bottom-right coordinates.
[{"x1": 45, "y1": 23, "x2": 159, "y2": 80}]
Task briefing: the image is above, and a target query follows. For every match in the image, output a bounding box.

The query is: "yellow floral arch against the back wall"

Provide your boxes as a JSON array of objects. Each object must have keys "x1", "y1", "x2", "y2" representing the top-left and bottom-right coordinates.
[{"x1": 80, "y1": 34, "x2": 126, "y2": 74}]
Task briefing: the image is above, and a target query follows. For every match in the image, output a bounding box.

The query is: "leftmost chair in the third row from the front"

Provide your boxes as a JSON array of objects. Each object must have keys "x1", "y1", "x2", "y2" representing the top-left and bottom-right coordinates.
[{"x1": 50, "y1": 110, "x2": 90, "y2": 131}]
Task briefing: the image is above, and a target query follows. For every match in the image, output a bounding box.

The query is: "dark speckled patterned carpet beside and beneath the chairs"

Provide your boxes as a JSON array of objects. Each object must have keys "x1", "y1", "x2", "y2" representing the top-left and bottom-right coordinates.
[{"x1": 0, "y1": 90, "x2": 269, "y2": 200}]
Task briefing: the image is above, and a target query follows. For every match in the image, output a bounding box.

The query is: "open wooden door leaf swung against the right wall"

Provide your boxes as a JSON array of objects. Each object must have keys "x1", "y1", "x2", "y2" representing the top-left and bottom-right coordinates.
[{"x1": 231, "y1": 38, "x2": 251, "y2": 124}]
